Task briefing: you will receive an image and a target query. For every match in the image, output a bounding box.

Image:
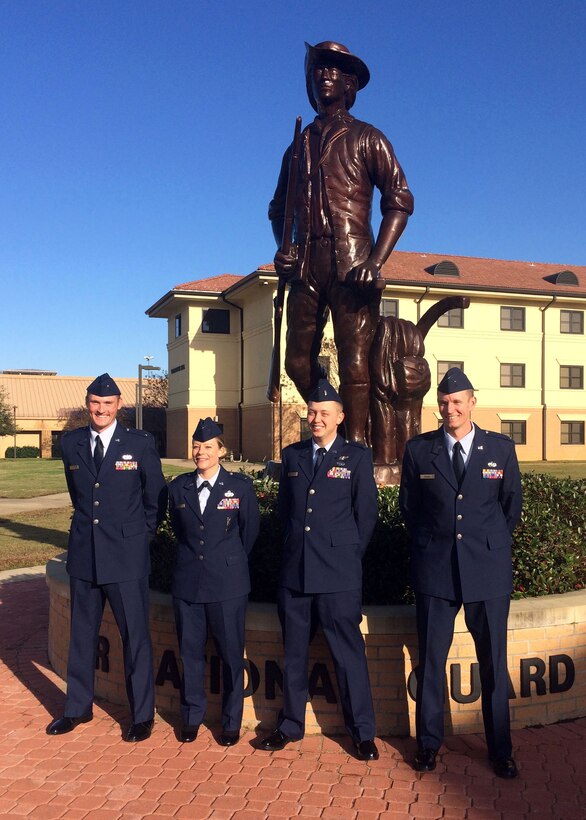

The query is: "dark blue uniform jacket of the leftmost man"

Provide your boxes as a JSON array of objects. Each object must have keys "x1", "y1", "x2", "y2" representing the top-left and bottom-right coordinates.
[{"x1": 61, "y1": 424, "x2": 167, "y2": 584}]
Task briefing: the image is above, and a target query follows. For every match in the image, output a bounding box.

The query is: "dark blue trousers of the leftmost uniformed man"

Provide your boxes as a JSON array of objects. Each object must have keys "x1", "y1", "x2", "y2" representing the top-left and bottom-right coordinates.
[{"x1": 64, "y1": 577, "x2": 155, "y2": 723}]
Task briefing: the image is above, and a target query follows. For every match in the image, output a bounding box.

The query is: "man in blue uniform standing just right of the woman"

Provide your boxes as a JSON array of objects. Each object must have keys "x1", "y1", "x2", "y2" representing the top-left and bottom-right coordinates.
[{"x1": 259, "y1": 379, "x2": 378, "y2": 760}]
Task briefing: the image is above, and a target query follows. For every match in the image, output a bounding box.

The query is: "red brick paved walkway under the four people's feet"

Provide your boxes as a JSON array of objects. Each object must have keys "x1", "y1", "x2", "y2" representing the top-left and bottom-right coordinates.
[{"x1": 0, "y1": 578, "x2": 586, "y2": 820}]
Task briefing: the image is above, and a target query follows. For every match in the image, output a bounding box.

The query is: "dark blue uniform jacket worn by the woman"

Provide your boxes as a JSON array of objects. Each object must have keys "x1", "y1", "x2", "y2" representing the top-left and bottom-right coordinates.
[{"x1": 169, "y1": 467, "x2": 260, "y2": 603}]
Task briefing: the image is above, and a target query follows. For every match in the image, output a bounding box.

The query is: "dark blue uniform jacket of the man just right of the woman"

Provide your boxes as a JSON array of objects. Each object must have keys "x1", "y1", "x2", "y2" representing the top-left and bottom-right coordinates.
[{"x1": 278, "y1": 436, "x2": 378, "y2": 593}]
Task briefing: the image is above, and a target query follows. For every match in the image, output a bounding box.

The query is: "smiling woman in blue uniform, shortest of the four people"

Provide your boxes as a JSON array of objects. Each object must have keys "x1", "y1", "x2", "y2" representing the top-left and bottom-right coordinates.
[{"x1": 169, "y1": 418, "x2": 260, "y2": 746}]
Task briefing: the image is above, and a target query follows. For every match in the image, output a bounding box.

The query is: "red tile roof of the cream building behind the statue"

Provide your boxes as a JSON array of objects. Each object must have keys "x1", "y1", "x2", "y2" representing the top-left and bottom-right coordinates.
[{"x1": 174, "y1": 251, "x2": 586, "y2": 296}]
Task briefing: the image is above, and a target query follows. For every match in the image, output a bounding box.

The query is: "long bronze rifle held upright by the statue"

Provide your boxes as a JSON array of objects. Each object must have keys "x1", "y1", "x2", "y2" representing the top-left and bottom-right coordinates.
[{"x1": 267, "y1": 117, "x2": 301, "y2": 403}]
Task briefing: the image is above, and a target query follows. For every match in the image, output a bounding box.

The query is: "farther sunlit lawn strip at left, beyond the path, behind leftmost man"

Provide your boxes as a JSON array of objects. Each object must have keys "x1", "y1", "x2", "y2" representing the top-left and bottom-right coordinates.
[{"x1": 0, "y1": 458, "x2": 189, "y2": 498}]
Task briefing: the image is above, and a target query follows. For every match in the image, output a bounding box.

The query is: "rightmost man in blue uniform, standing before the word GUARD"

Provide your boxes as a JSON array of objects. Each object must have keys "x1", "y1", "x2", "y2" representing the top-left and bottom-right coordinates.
[{"x1": 399, "y1": 368, "x2": 522, "y2": 778}]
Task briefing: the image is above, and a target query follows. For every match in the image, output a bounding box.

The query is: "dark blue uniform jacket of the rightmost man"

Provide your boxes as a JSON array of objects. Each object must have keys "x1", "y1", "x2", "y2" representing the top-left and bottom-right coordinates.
[{"x1": 399, "y1": 425, "x2": 522, "y2": 603}]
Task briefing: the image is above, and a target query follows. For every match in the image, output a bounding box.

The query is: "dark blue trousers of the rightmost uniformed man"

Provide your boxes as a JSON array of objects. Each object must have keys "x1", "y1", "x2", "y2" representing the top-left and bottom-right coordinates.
[{"x1": 416, "y1": 593, "x2": 512, "y2": 759}]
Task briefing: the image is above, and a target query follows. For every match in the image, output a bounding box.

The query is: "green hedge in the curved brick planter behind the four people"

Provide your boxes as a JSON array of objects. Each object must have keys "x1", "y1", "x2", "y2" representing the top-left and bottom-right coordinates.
[{"x1": 151, "y1": 474, "x2": 586, "y2": 604}]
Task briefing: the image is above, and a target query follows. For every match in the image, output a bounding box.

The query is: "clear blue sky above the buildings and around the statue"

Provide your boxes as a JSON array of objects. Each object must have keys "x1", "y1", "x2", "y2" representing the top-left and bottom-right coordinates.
[{"x1": 0, "y1": 0, "x2": 586, "y2": 376}]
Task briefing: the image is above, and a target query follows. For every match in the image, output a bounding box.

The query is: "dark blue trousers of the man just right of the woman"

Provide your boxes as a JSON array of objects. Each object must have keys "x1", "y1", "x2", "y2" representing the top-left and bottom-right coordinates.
[{"x1": 277, "y1": 587, "x2": 376, "y2": 741}]
